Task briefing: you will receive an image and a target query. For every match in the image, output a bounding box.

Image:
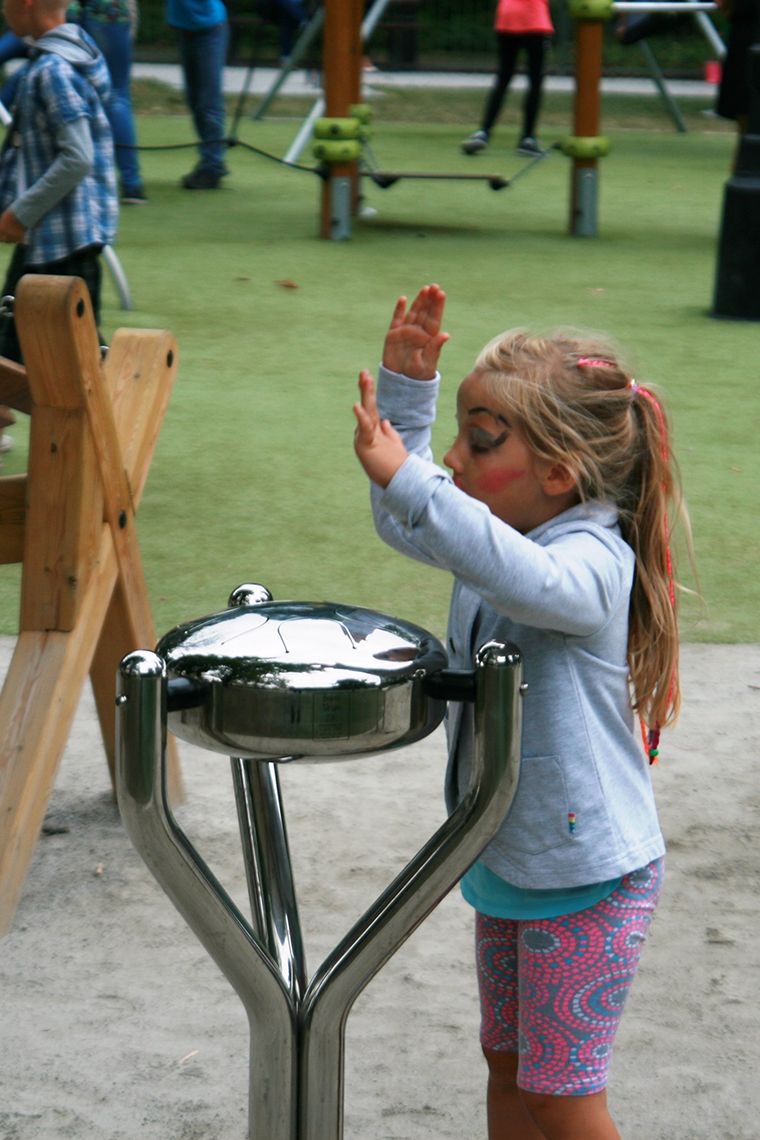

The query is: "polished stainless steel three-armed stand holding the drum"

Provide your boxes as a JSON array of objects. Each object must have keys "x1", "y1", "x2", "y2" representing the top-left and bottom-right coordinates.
[{"x1": 116, "y1": 597, "x2": 522, "y2": 1140}]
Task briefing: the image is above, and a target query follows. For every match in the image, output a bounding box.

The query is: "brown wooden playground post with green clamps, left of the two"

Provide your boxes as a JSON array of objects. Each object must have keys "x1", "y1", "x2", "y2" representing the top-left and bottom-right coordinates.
[{"x1": 320, "y1": 0, "x2": 362, "y2": 238}]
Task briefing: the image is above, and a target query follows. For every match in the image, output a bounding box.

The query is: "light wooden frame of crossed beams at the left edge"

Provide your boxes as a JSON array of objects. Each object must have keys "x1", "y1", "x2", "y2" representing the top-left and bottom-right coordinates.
[{"x1": 0, "y1": 276, "x2": 181, "y2": 936}]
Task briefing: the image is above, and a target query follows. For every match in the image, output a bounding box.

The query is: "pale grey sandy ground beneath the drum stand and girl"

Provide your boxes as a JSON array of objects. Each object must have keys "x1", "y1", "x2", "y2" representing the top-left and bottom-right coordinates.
[{"x1": 0, "y1": 638, "x2": 760, "y2": 1140}]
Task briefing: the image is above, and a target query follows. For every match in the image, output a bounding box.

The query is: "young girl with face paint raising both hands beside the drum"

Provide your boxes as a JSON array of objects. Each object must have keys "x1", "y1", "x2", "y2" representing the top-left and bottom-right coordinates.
[{"x1": 354, "y1": 285, "x2": 679, "y2": 1140}]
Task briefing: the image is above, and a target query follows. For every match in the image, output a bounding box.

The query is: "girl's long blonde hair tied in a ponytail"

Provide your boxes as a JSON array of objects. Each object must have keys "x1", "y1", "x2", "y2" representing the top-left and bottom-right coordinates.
[{"x1": 475, "y1": 329, "x2": 686, "y2": 730}]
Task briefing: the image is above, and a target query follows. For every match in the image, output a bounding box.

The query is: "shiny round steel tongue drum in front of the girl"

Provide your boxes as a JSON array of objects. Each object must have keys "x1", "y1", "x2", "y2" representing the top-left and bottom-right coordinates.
[{"x1": 156, "y1": 586, "x2": 447, "y2": 760}]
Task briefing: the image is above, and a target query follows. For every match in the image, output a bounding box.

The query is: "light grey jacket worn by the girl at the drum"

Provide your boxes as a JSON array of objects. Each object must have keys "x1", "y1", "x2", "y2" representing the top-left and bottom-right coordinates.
[{"x1": 371, "y1": 367, "x2": 664, "y2": 889}]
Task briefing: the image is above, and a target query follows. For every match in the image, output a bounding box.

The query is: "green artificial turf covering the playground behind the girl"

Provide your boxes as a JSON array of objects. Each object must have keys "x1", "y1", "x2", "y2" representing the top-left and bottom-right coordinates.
[{"x1": 0, "y1": 92, "x2": 760, "y2": 642}]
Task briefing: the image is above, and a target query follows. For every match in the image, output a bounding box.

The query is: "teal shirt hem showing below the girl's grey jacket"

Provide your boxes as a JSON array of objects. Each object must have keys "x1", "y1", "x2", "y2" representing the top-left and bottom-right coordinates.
[{"x1": 460, "y1": 863, "x2": 622, "y2": 919}]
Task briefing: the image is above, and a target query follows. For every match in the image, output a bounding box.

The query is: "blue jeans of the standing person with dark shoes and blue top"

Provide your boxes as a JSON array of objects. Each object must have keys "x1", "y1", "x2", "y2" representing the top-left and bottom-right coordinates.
[{"x1": 178, "y1": 19, "x2": 229, "y2": 174}]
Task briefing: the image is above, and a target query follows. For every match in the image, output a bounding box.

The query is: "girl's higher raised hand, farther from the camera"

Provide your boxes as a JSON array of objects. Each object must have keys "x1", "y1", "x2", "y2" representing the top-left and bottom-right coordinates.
[{"x1": 383, "y1": 285, "x2": 449, "y2": 380}]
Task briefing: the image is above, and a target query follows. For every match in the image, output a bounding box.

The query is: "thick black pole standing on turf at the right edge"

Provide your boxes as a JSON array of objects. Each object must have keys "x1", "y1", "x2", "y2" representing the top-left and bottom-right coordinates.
[{"x1": 712, "y1": 42, "x2": 760, "y2": 320}]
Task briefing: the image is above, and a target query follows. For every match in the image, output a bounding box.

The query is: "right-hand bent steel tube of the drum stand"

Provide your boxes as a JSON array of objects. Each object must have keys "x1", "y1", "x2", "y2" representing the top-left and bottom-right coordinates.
[{"x1": 299, "y1": 643, "x2": 522, "y2": 1140}]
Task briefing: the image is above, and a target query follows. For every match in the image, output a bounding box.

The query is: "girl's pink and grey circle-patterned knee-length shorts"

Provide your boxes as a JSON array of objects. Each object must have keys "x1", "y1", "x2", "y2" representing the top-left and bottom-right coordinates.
[{"x1": 475, "y1": 860, "x2": 664, "y2": 1097}]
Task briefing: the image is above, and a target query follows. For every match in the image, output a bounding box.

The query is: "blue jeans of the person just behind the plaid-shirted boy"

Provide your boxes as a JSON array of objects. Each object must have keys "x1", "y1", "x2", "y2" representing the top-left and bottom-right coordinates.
[{"x1": 82, "y1": 15, "x2": 142, "y2": 193}]
